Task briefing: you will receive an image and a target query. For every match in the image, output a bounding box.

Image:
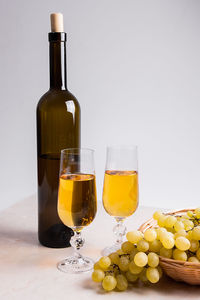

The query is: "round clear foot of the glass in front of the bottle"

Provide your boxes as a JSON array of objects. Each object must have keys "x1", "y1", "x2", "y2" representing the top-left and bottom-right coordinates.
[{"x1": 57, "y1": 256, "x2": 94, "y2": 274}]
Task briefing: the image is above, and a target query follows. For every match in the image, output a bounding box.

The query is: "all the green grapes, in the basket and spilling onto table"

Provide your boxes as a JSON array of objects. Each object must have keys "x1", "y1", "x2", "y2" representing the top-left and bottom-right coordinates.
[{"x1": 92, "y1": 208, "x2": 200, "y2": 291}]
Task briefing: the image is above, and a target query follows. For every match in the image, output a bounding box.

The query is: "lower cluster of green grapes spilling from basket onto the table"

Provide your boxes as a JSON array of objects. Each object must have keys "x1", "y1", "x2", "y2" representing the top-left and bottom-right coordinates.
[{"x1": 92, "y1": 229, "x2": 162, "y2": 291}]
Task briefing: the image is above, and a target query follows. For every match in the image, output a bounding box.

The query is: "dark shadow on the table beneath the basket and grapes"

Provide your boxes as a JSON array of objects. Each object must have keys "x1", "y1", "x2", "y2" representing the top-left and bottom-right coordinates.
[{"x1": 82, "y1": 275, "x2": 200, "y2": 299}]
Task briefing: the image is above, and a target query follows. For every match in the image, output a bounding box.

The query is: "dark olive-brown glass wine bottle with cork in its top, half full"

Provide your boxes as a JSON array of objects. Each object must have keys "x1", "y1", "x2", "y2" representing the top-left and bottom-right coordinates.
[{"x1": 37, "y1": 13, "x2": 80, "y2": 248}]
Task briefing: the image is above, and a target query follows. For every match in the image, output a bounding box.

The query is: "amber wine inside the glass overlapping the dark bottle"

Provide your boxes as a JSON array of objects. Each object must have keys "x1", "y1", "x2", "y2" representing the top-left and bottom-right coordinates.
[{"x1": 58, "y1": 174, "x2": 97, "y2": 230}]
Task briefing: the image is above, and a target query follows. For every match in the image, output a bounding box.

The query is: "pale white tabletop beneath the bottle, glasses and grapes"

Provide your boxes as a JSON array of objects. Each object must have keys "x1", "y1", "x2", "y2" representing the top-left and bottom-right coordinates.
[{"x1": 0, "y1": 197, "x2": 200, "y2": 300}]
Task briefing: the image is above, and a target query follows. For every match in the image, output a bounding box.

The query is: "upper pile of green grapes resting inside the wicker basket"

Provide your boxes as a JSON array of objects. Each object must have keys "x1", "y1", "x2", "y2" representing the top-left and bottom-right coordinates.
[{"x1": 153, "y1": 208, "x2": 200, "y2": 263}]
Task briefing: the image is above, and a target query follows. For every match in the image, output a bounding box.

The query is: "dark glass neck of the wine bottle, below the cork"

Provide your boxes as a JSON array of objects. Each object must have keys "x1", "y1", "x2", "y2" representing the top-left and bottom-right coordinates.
[{"x1": 49, "y1": 32, "x2": 67, "y2": 90}]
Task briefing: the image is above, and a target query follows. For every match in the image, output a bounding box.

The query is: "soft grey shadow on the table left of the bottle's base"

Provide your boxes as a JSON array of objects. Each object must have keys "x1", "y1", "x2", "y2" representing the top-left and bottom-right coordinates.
[{"x1": 0, "y1": 228, "x2": 39, "y2": 246}]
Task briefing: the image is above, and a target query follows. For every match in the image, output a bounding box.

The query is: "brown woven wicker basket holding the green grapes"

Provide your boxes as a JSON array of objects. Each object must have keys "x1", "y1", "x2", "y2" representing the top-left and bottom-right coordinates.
[{"x1": 139, "y1": 209, "x2": 200, "y2": 285}]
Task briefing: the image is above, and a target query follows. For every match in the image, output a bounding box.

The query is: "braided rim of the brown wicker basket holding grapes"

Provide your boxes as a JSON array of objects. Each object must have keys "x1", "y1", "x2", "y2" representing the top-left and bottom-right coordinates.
[{"x1": 138, "y1": 208, "x2": 200, "y2": 269}]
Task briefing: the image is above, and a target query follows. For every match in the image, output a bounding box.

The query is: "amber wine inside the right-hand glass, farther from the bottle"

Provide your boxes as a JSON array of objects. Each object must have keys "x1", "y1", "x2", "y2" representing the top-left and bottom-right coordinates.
[{"x1": 103, "y1": 170, "x2": 138, "y2": 217}]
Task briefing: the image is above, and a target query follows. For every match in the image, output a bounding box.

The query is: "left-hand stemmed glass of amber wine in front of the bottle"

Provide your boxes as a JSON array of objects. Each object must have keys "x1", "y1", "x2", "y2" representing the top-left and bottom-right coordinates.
[{"x1": 57, "y1": 148, "x2": 97, "y2": 273}]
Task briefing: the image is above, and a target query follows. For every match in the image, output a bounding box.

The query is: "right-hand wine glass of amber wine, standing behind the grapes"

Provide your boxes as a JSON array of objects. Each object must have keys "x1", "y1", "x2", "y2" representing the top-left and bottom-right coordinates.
[{"x1": 103, "y1": 146, "x2": 138, "y2": 255}]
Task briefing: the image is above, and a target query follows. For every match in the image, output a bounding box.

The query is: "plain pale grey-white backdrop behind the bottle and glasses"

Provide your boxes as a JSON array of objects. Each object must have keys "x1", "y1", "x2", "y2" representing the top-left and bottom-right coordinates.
[{"x1": 0, "y1": 0, "x2": 200, "y2": 209}]
